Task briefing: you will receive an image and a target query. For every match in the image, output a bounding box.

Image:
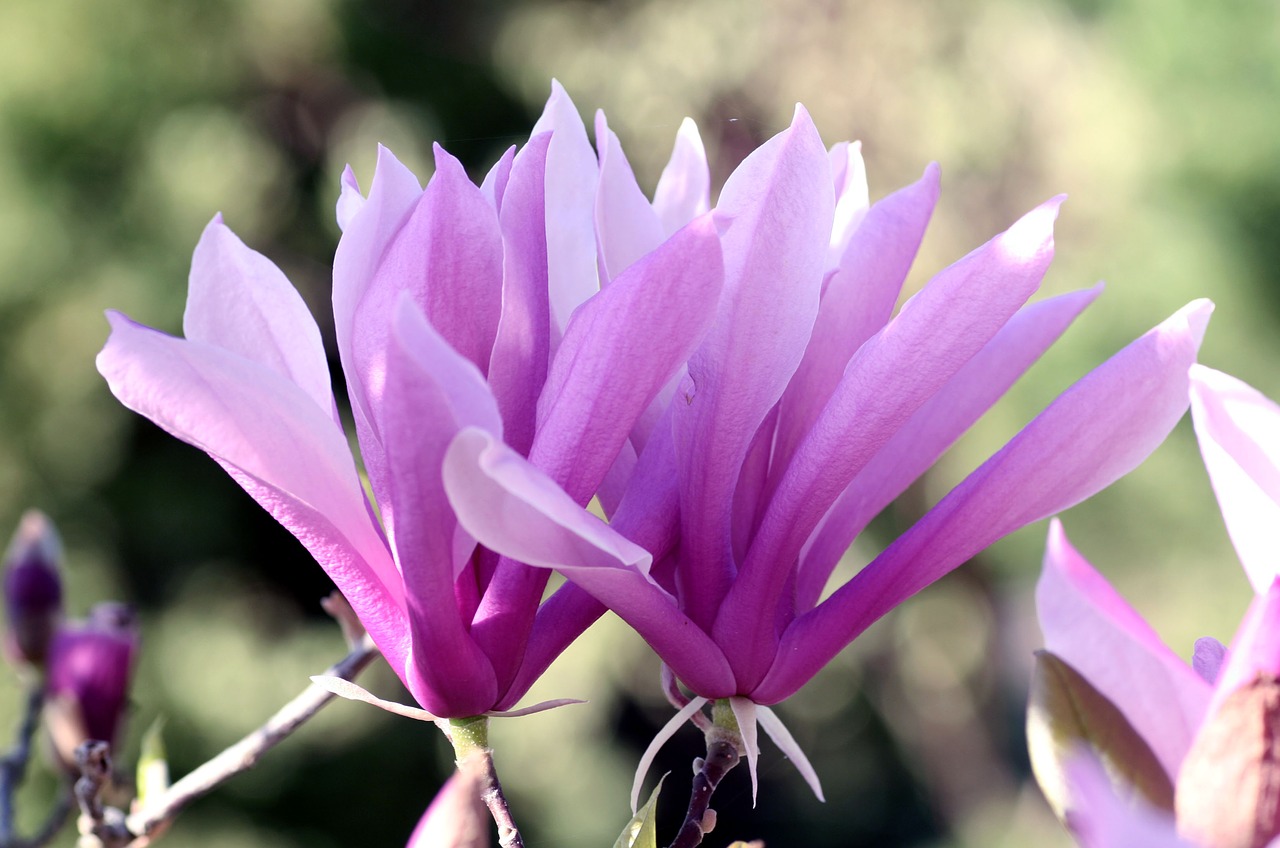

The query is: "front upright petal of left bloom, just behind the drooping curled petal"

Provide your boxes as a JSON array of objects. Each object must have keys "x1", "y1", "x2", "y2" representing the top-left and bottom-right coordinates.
[{"x1": 379, "y1": 302, "x2": 500, "y2": 717}]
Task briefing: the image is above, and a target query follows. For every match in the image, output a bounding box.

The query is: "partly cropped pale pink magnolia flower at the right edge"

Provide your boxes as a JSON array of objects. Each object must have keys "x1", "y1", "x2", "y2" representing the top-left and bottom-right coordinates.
[{"x1": 1028, "y1": 365, "x2": 1280, "y2": 848}]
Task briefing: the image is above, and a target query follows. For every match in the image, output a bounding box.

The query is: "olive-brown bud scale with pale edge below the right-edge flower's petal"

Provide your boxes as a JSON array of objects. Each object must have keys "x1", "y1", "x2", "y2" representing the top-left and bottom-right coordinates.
[{"x1": 1027, "y1": 651, "x2": 1174, "y2": 822}]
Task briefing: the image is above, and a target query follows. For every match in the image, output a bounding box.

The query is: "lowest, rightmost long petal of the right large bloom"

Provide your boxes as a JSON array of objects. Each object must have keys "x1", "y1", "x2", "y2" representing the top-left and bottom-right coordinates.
[{"x1": 753, "y1": 301, "x2": 1212, "y2": 703}]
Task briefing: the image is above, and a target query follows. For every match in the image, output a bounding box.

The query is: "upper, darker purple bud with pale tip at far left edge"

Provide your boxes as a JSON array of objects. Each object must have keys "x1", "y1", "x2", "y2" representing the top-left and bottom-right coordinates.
[{"x1": 4, "y1": 510, "x2": 63, "y2": 666}]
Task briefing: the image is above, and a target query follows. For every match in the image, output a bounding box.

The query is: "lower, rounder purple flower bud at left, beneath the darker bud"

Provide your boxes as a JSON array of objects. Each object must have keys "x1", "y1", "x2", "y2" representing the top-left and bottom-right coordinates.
[{"x1": 45, "y1": 603, "x2": 138, "y2": 772}]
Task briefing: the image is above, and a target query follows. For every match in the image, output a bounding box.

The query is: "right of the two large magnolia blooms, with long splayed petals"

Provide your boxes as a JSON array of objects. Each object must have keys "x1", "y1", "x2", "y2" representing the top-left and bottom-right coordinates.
[{"x1": 444, "y1": 108, "x2": 1211, "y2": 789}]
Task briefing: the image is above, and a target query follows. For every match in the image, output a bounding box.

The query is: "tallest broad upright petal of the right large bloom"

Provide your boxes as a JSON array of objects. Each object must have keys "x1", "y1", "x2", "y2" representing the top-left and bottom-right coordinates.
[{"x1": 673, "y1": 106, "x2": 835, "y2": 626}]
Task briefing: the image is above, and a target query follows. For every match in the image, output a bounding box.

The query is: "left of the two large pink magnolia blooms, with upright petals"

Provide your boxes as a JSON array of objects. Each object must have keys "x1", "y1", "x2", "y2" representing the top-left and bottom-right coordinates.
[{"x1": 97, "y1": 86, "x2": 723, "y2": 717}]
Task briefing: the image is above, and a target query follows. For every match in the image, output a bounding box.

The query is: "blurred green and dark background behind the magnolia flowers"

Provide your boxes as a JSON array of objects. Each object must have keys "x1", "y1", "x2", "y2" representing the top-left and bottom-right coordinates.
[{"x1": 0, "y1": 0, "x2": 1280, "y2": 848}]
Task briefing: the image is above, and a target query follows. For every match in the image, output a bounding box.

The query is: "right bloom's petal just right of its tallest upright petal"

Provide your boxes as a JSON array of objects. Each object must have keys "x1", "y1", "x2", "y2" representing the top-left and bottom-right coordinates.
[{"x1": 777, "y1": 165, "x2": 938, "y2": 469}]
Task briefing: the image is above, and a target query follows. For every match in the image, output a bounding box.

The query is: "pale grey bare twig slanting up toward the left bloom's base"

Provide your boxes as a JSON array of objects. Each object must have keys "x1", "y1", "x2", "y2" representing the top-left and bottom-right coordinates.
[{"x1": 127, "y1": 637, "x2": 378, "y2": 838}]
